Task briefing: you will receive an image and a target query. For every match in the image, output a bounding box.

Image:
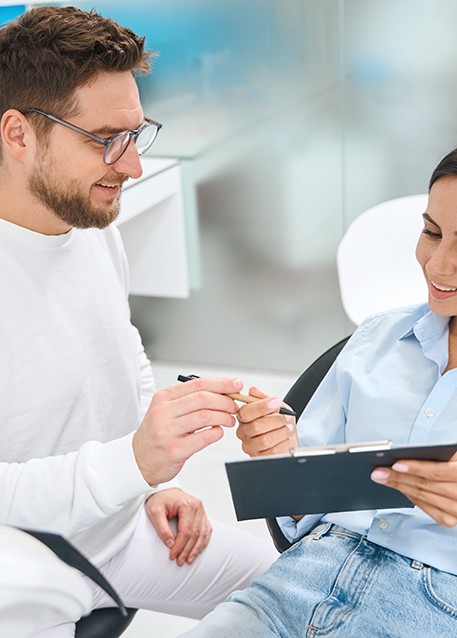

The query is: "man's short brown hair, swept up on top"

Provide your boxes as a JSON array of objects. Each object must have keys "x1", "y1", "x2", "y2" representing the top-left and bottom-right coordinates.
[{"x1": 0, "y1": 6, "x2": 153, "y2": 133}]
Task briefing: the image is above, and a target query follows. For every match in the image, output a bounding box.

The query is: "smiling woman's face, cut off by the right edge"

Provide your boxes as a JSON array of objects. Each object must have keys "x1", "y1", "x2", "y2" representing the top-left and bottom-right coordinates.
[{"x1": 416, "y1": 176, "x2": 457, "y2": 317}]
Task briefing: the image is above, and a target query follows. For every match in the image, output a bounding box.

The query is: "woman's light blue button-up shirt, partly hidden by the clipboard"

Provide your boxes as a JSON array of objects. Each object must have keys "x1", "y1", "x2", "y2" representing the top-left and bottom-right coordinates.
[{"x1": 278, "y1": 305, "x2": 457, "y2": 574}]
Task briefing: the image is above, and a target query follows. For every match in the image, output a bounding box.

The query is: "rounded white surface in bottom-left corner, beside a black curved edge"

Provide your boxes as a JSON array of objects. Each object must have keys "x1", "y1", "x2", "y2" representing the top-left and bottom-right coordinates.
[{"x1": 0, "y1": 526, "x2": 92, "y2": 638}]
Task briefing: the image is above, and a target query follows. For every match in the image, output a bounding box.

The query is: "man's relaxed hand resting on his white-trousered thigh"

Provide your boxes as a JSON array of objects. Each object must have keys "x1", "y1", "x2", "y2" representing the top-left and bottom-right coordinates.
[{"x1": 145, "y1": 488, "x2": 212, "y2": 567}]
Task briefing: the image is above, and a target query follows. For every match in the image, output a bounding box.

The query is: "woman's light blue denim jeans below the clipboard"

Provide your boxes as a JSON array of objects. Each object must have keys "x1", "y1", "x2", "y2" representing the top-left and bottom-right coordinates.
[{"x1": 182, "y1": 523, "x2": 457, "y2": 638}]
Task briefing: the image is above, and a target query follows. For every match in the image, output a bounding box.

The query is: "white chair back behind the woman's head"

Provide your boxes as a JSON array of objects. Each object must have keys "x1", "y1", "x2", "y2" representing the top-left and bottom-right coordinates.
[{"x1": 337, "y1": 195, "x2": 428, "y2": 325}]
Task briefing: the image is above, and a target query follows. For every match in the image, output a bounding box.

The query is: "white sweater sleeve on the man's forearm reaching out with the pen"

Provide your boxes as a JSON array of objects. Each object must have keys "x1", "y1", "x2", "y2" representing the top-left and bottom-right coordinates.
[{"x1": 0, "y1": 434, "x2": 153, "y2": 537}]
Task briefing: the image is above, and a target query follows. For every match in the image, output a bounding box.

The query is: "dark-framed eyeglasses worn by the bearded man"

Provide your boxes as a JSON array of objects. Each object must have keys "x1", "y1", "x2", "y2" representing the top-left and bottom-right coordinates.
[{"x1": 24, "y1": 109, "x2": 162, "y2": 165}]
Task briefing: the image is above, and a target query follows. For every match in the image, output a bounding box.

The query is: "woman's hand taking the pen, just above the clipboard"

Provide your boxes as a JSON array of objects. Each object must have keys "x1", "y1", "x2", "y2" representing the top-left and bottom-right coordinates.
[{"x1": 237, "y1": 388, "x2": 298, "y2": 456}]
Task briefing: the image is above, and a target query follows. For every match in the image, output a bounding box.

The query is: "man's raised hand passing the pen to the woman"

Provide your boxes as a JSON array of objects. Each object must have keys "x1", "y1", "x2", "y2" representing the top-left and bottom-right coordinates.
[{"x1": 133, "y1": 378, "x2": 243, "y2": 485}]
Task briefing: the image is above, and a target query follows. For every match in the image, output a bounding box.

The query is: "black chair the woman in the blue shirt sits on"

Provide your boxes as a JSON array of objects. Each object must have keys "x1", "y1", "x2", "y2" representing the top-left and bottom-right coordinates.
[{"x1": 266, "y1": 337, "x2": 349, "y2": 553}]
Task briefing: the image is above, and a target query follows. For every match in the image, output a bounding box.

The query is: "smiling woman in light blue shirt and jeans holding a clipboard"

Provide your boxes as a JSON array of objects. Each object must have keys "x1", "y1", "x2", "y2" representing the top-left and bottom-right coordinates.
[{"x1": 181, "y1": 149, "x2": 457, "y2": 638}]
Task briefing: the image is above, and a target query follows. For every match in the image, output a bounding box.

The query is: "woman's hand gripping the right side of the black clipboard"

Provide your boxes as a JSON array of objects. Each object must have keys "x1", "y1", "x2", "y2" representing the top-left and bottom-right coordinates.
[{"x1": 371, "y1": 454, "x2": 457, "y2": 527}]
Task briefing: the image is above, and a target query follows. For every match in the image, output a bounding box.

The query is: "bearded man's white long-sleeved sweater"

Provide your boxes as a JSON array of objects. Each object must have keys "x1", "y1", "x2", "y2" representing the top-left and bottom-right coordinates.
[{"x1": 0, "y1": 219, "x2": 154, "y2": 565}]
